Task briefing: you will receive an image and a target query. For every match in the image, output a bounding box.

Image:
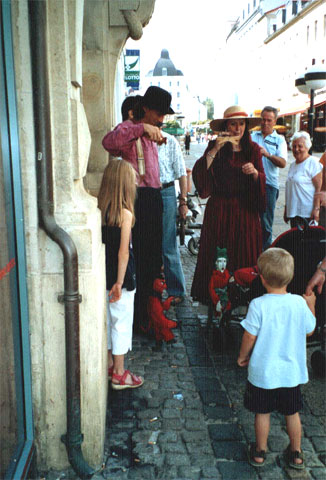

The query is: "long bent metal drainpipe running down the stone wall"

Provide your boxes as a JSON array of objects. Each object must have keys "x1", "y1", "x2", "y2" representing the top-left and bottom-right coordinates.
[{"x1": 29, "y1": 0, "x2": 95, "y2": 479}]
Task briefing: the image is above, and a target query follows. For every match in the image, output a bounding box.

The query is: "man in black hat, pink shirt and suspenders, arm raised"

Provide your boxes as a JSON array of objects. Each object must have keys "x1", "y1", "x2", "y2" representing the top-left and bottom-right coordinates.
[{"x1": 102, "y1": 86, "x2": 174, "y2": 331}]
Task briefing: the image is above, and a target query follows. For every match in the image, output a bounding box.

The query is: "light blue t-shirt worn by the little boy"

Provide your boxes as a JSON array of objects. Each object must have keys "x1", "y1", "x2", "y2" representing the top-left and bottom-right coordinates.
[{"x1": 241, "y1": 293, "x2": 316, "y2": 389}]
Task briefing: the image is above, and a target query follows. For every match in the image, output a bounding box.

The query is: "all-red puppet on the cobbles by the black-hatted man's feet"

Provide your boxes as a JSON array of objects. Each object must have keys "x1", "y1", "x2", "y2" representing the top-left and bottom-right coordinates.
[{"x1": 148, "y1": 278, "x2": 177, "y2": 343}]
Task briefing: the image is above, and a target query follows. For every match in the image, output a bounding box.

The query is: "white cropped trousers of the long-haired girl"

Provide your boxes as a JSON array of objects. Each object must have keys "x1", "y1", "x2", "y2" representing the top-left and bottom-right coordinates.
[{"x1": 106, "y1": 288, "x2": 136, "y2": 355}]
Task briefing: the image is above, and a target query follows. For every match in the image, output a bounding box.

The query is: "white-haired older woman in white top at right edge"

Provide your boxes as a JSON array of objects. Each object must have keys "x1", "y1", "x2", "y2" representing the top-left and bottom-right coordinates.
[{"x1": 284, "y1": 132, "x2": 322, "y2": 227}]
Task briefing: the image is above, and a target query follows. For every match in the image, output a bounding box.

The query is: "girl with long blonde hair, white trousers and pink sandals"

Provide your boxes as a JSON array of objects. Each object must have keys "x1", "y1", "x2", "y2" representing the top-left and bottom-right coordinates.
[{"x1": 98, "y1": 159, "x2": 144, "y2": 390}]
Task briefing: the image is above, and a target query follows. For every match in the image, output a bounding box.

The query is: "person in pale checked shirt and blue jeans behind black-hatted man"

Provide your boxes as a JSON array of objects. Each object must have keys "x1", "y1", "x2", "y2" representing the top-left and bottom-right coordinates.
[{"x1": 158, "y1": 132, "x2": 188, "y2": 304}]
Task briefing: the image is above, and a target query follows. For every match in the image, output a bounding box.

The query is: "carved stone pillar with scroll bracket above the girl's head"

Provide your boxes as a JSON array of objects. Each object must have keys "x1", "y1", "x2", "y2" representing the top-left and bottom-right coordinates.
[{"x1": 83, "y1": 0, "x2": 155, "y2": 195}]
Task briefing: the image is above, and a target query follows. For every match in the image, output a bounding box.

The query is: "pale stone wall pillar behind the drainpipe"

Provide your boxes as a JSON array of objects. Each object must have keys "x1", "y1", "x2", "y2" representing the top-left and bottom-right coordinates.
[{"x1": 12, "y1": 0, "x2": 107, "y2": 469}]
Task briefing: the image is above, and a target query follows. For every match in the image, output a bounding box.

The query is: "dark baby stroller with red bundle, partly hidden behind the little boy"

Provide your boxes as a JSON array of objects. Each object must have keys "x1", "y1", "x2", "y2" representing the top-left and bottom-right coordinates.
[{"x1": 209, "y1": 219, "x2": 326, "y2": 375}]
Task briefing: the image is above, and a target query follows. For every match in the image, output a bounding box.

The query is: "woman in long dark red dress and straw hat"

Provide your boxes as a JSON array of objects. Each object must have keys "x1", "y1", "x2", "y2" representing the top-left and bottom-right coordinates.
[{"x1": 191, "y1": 105, "x2": 266, "y2": 304}]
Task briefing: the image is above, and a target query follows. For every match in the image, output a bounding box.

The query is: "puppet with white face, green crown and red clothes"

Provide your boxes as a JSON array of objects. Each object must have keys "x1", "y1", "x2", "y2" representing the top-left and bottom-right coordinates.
[{"x1": 208, "y1": 247, "x2": 231, "y2": 317}]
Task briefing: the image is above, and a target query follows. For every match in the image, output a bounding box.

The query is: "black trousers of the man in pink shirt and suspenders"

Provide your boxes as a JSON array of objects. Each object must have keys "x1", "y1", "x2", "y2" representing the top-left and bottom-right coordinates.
[{"x1": 132, "y1": 187, "x2": 163, "y2": 331}]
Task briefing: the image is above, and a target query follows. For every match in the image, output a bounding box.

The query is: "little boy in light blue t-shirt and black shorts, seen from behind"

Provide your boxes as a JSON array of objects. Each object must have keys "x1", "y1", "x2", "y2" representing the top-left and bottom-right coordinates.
[{"x1": 238, "y1": 248, "x2": 316, "y2": 469}]
